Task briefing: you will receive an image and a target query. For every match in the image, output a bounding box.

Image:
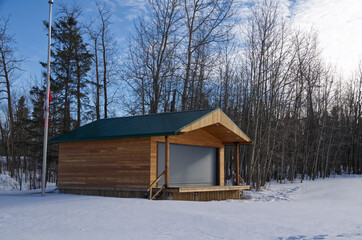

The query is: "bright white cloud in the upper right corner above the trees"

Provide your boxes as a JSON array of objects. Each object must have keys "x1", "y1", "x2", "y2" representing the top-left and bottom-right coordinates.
[{"x1": 293, "y1": 0, "x2": 362, "y2": 76}]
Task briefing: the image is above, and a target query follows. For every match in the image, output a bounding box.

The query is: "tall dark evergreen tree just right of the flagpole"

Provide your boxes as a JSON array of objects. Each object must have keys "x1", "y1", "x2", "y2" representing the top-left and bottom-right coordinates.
[{"x1": 42, "y1": 8, "x2": 92, "y2": 132}]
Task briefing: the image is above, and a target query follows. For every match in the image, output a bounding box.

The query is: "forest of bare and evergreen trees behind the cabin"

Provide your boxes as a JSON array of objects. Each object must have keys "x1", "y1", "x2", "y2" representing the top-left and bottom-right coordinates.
[{"x1": 0, "y1": 0, "x2": 362, "y2": 189}]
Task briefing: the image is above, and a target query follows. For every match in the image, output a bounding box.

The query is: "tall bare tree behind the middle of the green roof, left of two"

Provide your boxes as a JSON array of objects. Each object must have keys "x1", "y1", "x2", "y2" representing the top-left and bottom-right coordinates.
[{"x1": 125, "y1": 0, "x2": 180, "y2": 114}]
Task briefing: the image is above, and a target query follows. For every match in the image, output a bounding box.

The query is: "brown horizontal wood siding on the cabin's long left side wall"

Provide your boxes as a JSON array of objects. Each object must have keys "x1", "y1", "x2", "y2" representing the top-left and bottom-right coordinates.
[{"x1": 58, "y1": 138, "x2": 151, "y2": 188}]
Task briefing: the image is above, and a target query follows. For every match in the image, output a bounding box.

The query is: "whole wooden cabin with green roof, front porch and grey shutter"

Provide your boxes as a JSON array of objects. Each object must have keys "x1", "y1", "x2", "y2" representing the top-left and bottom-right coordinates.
[{"x1": 51, "y1": 109, "x2": 252, "y2": 201}]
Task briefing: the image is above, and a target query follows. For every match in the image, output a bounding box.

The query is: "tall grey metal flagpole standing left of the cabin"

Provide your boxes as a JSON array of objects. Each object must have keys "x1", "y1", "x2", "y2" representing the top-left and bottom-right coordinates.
[{"x1": 41, "y1": 0, "x2": 53, "y2": 196}]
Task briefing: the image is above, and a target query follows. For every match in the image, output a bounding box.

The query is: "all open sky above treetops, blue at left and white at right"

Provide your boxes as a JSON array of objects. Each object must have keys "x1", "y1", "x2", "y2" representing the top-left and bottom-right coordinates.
[{"x1": 0, "y1": 0, "x2": 362, "y2": 94}]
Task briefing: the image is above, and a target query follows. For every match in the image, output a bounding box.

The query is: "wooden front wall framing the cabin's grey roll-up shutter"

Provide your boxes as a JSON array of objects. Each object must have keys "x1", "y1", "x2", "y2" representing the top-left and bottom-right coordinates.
[{"x1": 150, "y1": 129, "x2": 224, "y2": 185}]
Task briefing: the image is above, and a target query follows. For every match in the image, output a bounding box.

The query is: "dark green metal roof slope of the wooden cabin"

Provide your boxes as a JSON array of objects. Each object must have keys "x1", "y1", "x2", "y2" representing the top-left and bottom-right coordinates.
[{"x1": 50, "y1": 109, "x2": 217, "y2": 143}]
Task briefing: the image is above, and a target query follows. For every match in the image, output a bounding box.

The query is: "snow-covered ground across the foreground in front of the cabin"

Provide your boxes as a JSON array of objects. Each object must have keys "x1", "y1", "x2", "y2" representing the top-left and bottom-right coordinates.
[{"x1": 0, "y1": 176, "x2": 362, "y2": 240}]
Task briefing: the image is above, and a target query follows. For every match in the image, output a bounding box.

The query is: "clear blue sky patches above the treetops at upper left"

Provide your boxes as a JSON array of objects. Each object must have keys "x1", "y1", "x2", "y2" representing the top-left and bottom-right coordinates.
[{"x1": 0, "y1": 0, "x2": 146, "y2": 91}]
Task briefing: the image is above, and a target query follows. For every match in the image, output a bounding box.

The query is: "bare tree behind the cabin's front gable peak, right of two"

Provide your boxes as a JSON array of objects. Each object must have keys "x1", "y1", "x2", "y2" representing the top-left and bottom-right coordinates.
[{"x1": 181, "y1": 0, "x2": 233, "y2": 110}]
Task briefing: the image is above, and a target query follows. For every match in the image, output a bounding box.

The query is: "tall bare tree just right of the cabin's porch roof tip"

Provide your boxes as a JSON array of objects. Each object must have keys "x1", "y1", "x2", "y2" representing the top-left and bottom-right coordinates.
[{"x1": 239, "y1": 0, "x2": 289, "y2": 188}]
